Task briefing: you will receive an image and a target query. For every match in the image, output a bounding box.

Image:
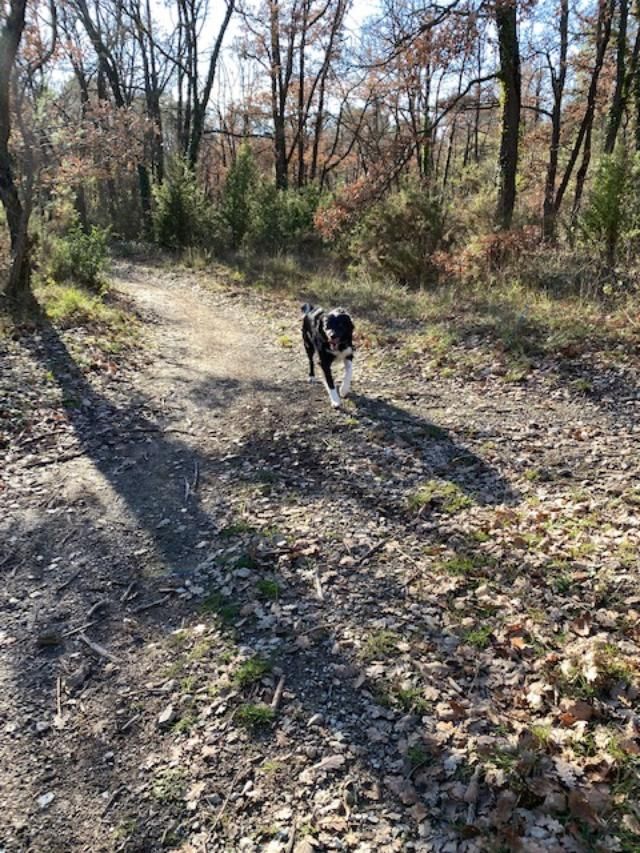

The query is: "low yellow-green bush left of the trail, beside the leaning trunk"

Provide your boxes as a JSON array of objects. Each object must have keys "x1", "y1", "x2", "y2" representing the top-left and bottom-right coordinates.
[{"x1": 46, "y1": 224, "x2": 109, "y2": 290}]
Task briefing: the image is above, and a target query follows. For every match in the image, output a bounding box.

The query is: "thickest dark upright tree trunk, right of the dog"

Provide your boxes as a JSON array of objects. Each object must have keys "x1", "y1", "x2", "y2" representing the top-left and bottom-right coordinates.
[{"x1": 495, "y1": 0, "x2": 521, "y2": 230}]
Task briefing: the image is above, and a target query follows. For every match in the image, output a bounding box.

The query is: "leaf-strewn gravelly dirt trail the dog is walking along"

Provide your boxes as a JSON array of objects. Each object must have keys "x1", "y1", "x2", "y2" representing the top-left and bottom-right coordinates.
[{"x1": 0, "y1": 264, "x2": 638, "y2": 853}]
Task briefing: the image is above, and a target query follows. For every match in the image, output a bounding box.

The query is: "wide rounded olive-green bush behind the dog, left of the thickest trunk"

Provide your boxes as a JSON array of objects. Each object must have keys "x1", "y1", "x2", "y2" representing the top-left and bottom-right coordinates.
[{"x1": 349, "y1": 181, "x2": 446, "y2": 287}]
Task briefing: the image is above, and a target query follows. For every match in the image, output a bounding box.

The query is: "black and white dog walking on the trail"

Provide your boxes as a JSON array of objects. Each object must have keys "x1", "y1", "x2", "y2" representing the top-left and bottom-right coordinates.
[{"x1": 302, "y1": 304, "x2": 353, "y2": 409}]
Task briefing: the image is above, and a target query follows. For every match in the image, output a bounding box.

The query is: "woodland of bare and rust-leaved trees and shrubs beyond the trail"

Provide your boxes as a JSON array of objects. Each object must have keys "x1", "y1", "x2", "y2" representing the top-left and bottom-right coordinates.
[{"x1": 0, "y1": 0, "x2": 640, "y2": 301}]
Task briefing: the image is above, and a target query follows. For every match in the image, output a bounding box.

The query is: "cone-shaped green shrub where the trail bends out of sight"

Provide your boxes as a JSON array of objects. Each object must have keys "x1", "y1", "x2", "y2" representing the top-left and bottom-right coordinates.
[{"x1": 153, "y1": 159, "x2": 228, "y2": 251}]
